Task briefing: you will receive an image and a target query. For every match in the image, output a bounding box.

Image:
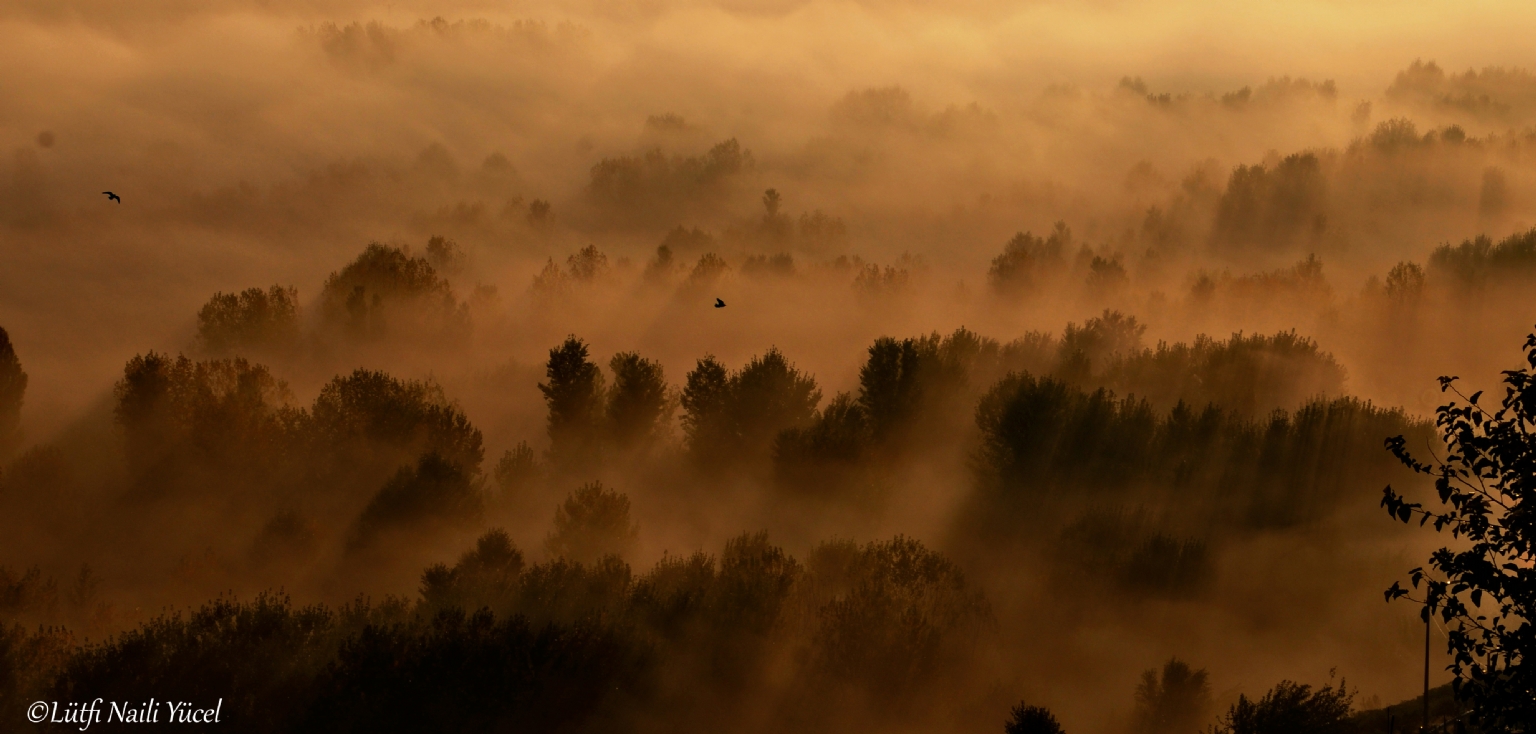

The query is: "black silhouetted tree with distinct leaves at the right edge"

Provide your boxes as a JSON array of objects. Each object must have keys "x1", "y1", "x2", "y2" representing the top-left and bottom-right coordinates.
[{"x1": 1381, "y1": 333, "x2": 1536, "y2": 731}]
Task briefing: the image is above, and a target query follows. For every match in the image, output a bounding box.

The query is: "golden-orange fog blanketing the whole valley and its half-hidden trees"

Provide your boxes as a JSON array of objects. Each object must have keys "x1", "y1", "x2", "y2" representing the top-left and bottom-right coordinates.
[{"x1": 0, "y1": 0, "x2": 1536, "y2": 734}]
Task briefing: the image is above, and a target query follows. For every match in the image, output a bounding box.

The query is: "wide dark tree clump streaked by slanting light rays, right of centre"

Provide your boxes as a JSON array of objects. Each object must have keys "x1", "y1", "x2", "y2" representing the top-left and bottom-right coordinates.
[{"x1": 974, "y1": 375, "x2": 1422, "y2": 527}]
